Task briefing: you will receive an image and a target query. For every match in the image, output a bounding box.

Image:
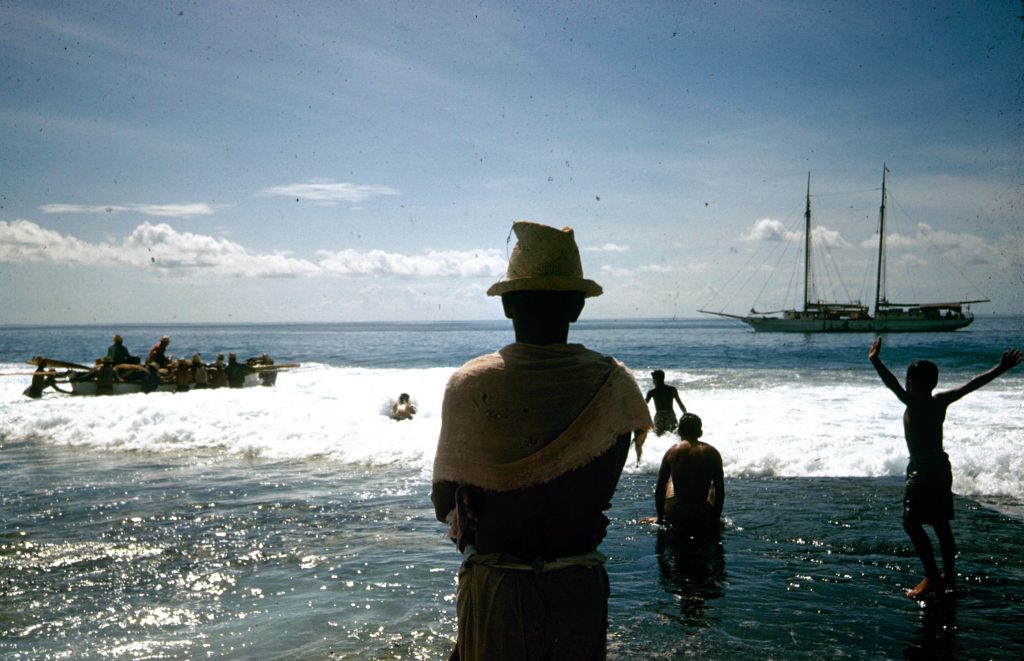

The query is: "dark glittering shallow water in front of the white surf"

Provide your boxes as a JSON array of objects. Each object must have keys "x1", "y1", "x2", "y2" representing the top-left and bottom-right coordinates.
[{"x1": 0, "y1": 442, "x2": 1024, "y2": 659}]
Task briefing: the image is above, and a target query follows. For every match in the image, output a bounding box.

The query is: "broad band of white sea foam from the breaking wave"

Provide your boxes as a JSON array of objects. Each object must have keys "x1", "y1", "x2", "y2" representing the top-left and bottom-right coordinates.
[{"x1": 0, "y1": 364, "x2": 1024, "y2": 499}]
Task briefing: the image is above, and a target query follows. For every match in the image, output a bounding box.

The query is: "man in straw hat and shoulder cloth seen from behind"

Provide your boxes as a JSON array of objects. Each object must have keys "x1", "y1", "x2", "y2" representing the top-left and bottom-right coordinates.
[{"x1": 431, "y1": 222, "x2": 651, "y2": 661}]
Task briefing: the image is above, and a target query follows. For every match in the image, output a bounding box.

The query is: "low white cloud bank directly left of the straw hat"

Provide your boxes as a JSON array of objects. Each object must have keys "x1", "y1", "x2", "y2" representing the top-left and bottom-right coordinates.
[{"x1": 316, "y1": 250, "x2": 505, "y2": 277}]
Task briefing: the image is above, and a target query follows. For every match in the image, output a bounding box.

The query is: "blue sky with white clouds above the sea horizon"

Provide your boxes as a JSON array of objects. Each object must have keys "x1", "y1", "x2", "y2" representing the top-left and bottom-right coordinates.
[{"x1": 0, "y1": 0, "x2": 1024, "y2": 324}]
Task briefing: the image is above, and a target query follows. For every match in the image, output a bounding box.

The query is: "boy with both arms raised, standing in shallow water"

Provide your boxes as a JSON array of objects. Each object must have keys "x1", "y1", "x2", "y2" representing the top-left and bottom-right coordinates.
[{"x1": 867, "y1": 337, "x2": 1021, "y2": 599}]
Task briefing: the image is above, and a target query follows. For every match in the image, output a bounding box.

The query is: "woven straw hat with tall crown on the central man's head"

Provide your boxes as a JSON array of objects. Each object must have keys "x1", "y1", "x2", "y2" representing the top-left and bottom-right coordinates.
[{"x1": 487, "y1": 220, "x2": 602, "y2": 298}]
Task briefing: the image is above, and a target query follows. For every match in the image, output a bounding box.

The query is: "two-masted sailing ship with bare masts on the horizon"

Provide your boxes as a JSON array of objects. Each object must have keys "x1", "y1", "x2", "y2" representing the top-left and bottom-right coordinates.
[{"x1": 698, "y1": 166, "x2": 989, "y2": 333}]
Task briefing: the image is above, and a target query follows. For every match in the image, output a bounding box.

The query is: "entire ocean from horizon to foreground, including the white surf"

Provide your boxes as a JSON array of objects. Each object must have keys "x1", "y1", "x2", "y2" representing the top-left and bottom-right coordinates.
[{"x1": 0, "y1": 319, "x2": 1024, "y2": 659}]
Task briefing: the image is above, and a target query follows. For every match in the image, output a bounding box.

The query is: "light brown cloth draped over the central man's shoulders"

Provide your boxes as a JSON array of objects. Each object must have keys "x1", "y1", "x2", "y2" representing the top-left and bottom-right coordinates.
[{"x1": 433, "y1": 343, "x2": 651, "y2": 491}]
